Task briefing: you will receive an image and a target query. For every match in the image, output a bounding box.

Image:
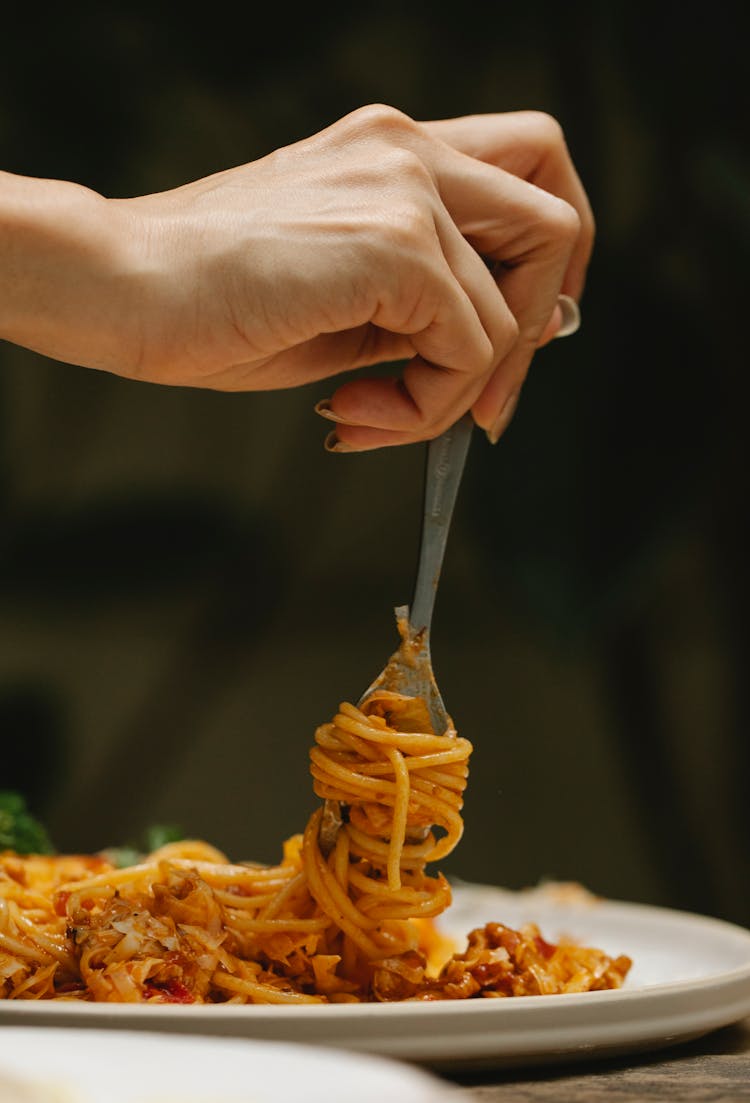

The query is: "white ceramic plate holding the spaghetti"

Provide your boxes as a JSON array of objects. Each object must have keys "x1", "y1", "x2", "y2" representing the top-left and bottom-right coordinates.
[{"x1": 0, "y1": 885, "x2": 750, "y2": 1065}]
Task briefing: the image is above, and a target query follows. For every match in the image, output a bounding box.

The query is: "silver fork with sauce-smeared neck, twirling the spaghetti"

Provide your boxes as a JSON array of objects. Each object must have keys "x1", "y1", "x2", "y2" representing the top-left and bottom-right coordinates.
[{"x1": 320, "y1": 414, "x2": 474, "y2": 854}]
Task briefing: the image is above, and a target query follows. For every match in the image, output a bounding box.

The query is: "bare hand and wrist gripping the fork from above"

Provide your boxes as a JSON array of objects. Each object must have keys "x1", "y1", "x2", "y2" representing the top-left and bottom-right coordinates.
[{"x1": 0, "y1": 105, "x2": 593, "y2": 451}]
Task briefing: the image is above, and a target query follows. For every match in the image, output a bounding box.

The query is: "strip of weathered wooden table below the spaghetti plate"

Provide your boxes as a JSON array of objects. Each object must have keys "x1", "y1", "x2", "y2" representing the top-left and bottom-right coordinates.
[{"x1": 444, "y1": 1018, "x2": 750, "y2": 1103}]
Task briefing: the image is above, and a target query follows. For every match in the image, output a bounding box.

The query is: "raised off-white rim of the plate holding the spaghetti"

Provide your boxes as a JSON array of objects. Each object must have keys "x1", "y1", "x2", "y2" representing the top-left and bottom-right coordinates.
[{"x1": 0, "y1": 881, "x2": 750, "y2": 1068}]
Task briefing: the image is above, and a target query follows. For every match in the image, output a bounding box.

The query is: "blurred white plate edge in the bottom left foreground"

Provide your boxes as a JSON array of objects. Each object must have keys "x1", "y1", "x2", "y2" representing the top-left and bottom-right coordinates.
[{"x1": 0, "y1": 1027, "x2": 447, "y2": 1103}]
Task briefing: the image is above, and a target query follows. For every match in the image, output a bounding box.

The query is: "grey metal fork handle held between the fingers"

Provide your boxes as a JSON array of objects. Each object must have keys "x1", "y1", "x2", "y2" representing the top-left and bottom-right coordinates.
[{"x1": 409, "y1": 414, "x2": 474, "y2": 636}]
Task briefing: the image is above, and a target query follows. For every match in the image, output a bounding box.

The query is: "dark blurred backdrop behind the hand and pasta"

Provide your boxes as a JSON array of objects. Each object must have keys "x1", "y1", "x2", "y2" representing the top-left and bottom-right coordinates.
[{"x1": 0, "y1": 0, "x2": 750, "y2": 924}]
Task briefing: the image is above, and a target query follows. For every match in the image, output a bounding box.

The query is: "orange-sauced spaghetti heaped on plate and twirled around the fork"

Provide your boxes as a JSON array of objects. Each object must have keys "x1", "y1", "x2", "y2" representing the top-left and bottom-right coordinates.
[{"x1": 0, "y1": 690, "x2": 631, "y2": 1004}]
